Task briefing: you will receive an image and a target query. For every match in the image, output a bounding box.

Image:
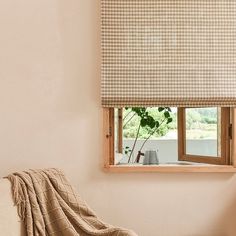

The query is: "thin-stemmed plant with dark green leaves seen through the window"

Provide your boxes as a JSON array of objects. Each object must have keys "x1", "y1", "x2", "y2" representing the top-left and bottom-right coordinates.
[{"x1": 123, "y1": 107, "x2": 173, "y2": 163}]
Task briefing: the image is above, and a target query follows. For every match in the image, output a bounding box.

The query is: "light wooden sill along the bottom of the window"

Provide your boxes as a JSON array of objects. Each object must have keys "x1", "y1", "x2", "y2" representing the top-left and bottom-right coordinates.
[{"x1": 104, "y1": 164, "x2": 236, "y2": 173}]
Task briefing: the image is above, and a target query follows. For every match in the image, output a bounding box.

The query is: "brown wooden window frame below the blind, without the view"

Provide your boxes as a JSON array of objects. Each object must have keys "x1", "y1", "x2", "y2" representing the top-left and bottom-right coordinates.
[{"x1": 103, "y1": 108, "x2": 236, "y2": 173}]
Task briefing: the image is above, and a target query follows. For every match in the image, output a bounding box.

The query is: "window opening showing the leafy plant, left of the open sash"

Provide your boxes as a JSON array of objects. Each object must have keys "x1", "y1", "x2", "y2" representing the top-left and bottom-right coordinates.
[{"x1": 115, "y1": 107, "x2": 178, "y2": 165}]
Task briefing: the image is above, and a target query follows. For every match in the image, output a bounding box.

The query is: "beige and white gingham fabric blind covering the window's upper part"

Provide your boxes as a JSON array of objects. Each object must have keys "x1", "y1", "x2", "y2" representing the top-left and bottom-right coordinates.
[{"x1": 101, "y1": 0, "x2": 236, "y2": 107}]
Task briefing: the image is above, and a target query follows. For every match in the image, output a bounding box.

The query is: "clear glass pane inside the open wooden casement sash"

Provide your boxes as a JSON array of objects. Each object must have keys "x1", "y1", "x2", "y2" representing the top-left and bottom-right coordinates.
[{"x1": 186, "y1": 107, "x2": 221, "y2": 157}]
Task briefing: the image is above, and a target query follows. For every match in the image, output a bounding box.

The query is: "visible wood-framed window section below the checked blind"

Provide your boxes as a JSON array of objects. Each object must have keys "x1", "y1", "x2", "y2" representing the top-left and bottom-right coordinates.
[{"x1": 104, "y1": 107, "x2": 236, "y2": 170}]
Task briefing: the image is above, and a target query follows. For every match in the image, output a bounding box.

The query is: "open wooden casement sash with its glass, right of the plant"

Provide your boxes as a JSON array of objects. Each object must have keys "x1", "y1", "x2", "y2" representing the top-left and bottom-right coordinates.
[{"x1": 178, "y1": 107, "x2": 231, "y2": 165}]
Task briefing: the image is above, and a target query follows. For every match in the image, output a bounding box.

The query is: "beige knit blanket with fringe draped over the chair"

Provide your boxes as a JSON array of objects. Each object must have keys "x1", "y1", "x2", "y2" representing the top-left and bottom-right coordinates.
[{"x1": 6, "y1": 169, "x2": 137, "y2": 236}]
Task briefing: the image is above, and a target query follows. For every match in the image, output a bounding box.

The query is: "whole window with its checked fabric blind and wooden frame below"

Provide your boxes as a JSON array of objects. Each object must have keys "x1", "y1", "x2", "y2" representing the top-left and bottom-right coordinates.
[{"x1": 101, "y1": 0, "x2": 236, "y2": 172}]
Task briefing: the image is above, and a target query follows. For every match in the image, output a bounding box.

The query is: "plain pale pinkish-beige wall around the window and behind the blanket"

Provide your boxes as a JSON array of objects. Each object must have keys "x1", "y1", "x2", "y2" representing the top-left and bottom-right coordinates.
[{"x1": 0, "y1": 0, "x2": 236, "y2": 236}]
